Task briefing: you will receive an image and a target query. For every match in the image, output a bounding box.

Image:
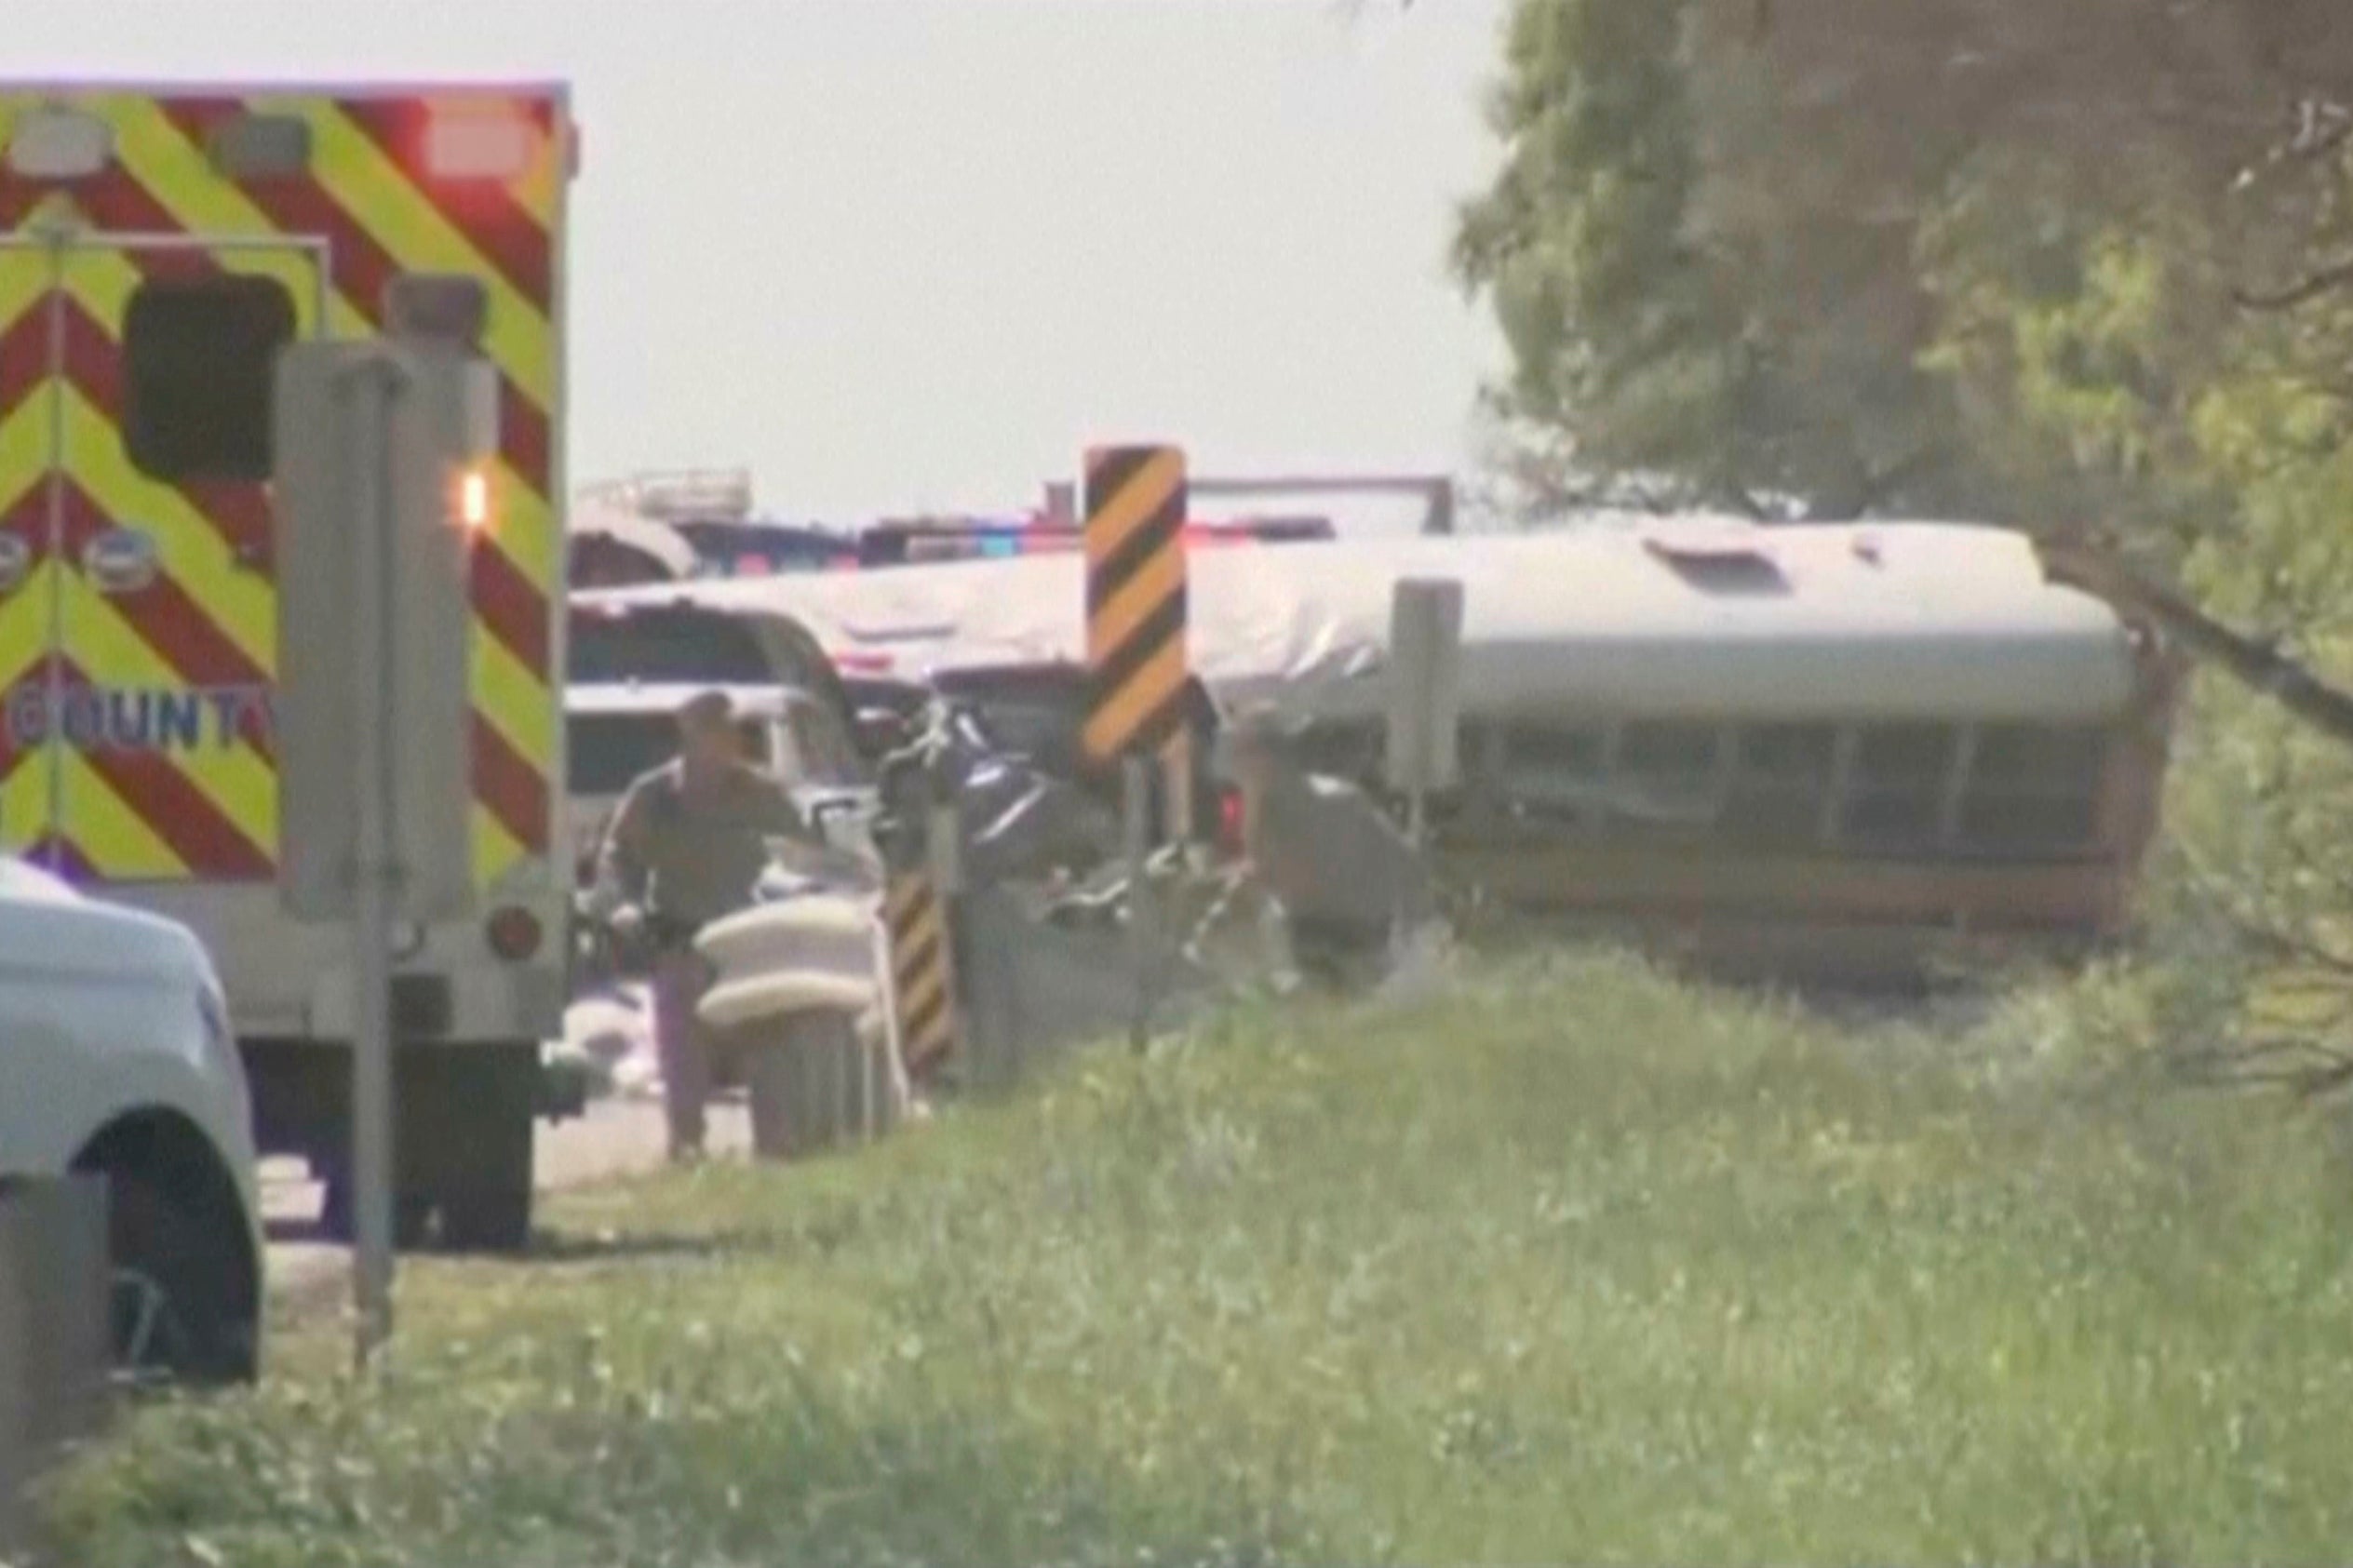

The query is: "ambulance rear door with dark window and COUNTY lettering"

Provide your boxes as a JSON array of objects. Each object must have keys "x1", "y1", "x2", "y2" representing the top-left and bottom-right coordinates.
[{"x1": 0, "y1": 223, "x2": 327, "y2": 884}]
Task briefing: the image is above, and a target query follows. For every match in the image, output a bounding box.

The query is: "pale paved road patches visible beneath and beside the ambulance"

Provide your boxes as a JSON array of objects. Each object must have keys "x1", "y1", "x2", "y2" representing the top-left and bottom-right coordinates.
[{"x1": 262, "y1": 1100, "x2": 750, "y2": 1305}]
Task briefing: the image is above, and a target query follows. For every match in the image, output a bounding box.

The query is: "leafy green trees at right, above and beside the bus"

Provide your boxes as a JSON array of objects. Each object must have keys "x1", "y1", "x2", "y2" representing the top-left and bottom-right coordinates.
[{"x1": 1454, "y1": 0, "x2": 2353, "y2": 1071}]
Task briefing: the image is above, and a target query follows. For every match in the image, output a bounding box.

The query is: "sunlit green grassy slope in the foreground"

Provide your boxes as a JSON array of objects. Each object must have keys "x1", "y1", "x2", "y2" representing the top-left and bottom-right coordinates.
[{"x1": 27, "y1": 959, "x2": 2353, "y2": 1568}]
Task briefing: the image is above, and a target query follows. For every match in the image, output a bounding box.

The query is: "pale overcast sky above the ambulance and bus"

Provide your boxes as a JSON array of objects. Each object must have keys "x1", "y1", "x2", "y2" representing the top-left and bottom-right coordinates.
[{"x1": 22, "y1": 0, "x2": 1501, "y2": 522}]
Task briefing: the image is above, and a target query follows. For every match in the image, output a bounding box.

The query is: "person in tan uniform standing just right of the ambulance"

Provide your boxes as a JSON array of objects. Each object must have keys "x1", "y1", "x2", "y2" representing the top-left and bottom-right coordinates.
[{"x1": 598, "y1": 691, "x2": 810, "y2": 1161}]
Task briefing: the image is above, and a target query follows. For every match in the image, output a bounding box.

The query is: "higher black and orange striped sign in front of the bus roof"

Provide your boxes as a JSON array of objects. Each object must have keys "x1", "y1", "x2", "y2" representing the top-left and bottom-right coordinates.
[{"x1": 1082, "y1": 447, "x2": 1186, "y2": 762}]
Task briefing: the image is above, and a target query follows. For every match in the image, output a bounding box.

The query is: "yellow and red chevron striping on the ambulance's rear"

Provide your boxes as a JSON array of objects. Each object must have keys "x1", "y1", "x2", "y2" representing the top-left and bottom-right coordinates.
[{"x1": 0, "y1": 89, "x2": 567, "y2": 879}]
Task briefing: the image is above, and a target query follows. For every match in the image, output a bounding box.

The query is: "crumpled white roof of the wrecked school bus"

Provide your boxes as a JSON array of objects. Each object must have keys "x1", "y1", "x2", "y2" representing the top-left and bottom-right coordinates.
[{"x1": 564, "y1": 517, "x2": 2134, "y2": 722}]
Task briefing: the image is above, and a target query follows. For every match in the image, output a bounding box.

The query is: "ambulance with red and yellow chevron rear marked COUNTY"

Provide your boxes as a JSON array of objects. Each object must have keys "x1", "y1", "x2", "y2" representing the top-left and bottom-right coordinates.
[{"x1": 0, "y1": 82, "x2": 579, "y2": 1251}]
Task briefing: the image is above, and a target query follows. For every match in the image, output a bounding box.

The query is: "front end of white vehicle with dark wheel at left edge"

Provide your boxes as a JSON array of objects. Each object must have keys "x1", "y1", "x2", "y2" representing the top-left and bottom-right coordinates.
[{"x1": 0, "y1": 856, "x2": 263, "y2": 1382}]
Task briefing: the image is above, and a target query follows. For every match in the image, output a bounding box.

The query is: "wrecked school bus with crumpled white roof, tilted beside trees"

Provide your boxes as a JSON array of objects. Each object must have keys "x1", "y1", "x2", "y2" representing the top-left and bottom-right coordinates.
[{"x1": 573, "y1": 519, "x2": 2179, "y2": 980}]
